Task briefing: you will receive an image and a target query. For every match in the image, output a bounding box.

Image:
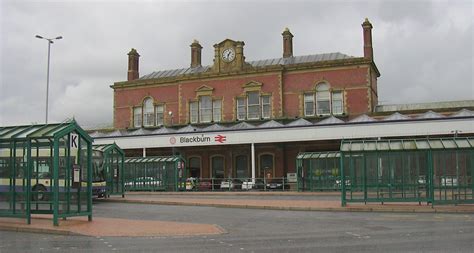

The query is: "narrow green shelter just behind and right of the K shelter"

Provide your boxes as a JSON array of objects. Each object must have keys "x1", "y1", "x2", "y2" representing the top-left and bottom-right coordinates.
[{"x1": 92, "y1": 143, "x2": 125, "y2": 197}]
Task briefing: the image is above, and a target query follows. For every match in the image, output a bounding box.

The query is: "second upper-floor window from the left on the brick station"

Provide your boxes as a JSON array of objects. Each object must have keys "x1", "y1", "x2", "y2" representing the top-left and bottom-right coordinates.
[{"x1": 189, "y1": 96, "x2": 222, "y2": 123}]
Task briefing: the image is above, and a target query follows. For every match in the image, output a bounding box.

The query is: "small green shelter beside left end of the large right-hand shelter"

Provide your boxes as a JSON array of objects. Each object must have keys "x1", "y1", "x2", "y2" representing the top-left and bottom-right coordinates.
[{"x1": 296, "y1": 151, "x2": 341, "y2": 191}]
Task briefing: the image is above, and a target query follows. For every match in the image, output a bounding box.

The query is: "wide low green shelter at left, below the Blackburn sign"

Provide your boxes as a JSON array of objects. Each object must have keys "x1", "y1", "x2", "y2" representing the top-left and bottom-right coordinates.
[{"x1": 124, "y1": 156, "x2": 186, "y2": 191}]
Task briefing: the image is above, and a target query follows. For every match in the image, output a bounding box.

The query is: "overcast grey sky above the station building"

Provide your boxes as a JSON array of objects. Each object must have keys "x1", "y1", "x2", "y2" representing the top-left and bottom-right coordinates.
[{"x1": 0, "y1": 0, "x2": 474, "y2": 128}]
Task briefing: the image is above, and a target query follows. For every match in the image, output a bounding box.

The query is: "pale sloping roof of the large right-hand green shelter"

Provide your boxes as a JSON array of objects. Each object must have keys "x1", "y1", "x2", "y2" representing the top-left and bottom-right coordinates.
[{"x1": 341, "y1": 137, "x2": 474, "y2": 152}]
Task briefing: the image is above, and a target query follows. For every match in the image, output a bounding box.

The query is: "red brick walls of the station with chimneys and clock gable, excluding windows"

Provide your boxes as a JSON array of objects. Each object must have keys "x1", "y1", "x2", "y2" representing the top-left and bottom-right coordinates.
[{"x1": 113, "y1": 20, "x2": 380, "y2": 181}]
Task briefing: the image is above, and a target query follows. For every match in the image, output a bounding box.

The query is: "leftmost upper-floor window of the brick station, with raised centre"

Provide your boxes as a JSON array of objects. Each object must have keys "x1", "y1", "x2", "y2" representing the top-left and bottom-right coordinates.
[{"x1": 133, "y1": 97, "x2": 165, "y2": 128}]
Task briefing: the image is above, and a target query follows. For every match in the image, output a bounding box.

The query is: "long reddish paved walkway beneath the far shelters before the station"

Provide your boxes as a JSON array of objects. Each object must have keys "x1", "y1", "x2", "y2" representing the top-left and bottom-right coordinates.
[{"x1": 101, "y1": 192, "x2": 474, "y2": 213}]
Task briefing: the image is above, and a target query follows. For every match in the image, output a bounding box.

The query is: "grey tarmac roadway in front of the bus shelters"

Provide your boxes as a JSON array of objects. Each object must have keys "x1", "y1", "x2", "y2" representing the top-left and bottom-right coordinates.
[{"x1": 0, "y1": 202, "x2": 474, "y2": 253}]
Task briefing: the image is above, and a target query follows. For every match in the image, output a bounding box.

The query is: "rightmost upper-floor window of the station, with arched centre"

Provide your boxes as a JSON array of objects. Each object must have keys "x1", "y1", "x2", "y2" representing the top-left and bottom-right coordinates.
[{"x1": 304, "y1": 83, "x2": 344, "y2": 116}]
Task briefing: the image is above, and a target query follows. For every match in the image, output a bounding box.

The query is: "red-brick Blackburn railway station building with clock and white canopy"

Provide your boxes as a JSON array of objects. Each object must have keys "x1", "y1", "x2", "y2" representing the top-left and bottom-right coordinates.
[{"x1": 91, "y1": 19, "x2": 474, "y2": 184}]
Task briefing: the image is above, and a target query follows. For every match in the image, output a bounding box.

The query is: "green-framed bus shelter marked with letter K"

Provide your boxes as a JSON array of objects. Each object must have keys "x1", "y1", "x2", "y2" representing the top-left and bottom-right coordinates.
[{"x1": 0, "y1": 120, "x2": 93, "y2": 226}]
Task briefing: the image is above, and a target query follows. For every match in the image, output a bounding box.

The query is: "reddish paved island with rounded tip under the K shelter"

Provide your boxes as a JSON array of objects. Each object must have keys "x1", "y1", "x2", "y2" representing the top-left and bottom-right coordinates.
[{"x1": 0, "y1": 216, "x2": 225, "y2": 237}]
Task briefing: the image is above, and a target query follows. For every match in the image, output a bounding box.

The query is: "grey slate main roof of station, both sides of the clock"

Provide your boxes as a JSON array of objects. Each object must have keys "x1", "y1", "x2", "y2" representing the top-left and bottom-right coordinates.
[{"x1": 140, "y1": 52, "x2": 354, "y2": 80}]
